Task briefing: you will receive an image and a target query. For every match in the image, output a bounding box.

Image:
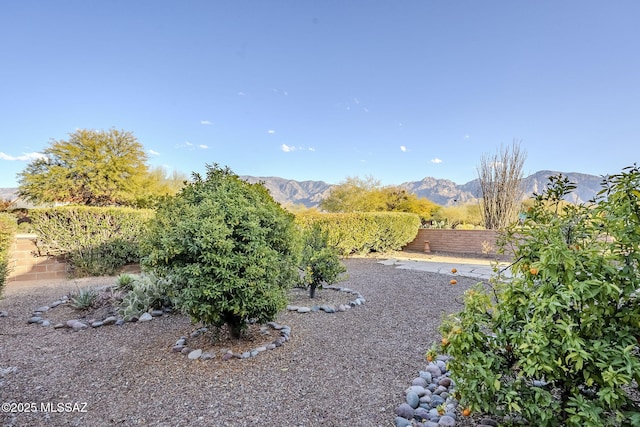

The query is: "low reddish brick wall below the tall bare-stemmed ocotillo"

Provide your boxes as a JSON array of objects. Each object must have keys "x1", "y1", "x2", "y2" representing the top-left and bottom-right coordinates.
[{"x1": 402, "y1": 228, "x2": 497, "y2": 256}]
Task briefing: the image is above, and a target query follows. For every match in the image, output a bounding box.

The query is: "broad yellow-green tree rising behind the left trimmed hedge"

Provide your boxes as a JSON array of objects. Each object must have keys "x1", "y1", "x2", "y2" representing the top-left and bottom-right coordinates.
[{"x1": 18, "y1": 129, "x2": 148, "y2": 206}]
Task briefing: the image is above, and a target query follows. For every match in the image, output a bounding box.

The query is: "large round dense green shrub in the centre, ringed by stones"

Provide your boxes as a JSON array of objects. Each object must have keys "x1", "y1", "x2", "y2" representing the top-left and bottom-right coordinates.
[{"x1": 143, "y1": 165, "x2": 298, "y2": 336}]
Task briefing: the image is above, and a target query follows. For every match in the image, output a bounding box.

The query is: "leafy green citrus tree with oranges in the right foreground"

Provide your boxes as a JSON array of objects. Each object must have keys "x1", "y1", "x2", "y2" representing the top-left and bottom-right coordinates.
[{"x1": 434, "y1": 167, "x2": 640, "y2": 426}]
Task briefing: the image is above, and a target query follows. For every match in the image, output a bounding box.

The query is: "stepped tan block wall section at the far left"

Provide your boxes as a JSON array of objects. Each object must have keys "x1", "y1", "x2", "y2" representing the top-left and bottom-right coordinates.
[{"x1": 7, "y1": 234, "x2": 68, "y2": 283}]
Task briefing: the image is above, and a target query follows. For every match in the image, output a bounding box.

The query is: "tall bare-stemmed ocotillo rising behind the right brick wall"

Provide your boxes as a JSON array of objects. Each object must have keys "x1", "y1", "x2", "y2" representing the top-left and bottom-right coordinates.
[{"x1": 478, "y1": 141, "x2": 526, "y2": 230}]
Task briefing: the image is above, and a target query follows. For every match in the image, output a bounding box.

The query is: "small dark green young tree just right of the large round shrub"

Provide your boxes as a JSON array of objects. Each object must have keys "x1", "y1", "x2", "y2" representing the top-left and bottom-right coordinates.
[{"x1": 300, "y1": 224, "x2": 347, "y2": 298}]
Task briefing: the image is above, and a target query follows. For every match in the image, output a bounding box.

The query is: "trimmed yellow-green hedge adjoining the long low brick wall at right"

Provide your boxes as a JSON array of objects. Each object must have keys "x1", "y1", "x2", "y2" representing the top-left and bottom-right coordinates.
[{"x1": 296, "y1": 212, "x2": 420, "y2": 255}]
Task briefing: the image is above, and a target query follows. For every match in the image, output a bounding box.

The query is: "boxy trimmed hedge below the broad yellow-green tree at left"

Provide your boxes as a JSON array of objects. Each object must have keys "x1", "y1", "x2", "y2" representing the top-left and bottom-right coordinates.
[{"x1": 29, "y1": 206, "x2": 153, "y2": 276}]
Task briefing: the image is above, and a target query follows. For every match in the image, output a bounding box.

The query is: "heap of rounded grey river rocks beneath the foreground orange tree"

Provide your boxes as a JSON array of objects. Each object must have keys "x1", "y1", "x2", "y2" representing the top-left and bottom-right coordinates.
[{"x1": 395, "y1": 355, "x2": 498, "y2": 427}]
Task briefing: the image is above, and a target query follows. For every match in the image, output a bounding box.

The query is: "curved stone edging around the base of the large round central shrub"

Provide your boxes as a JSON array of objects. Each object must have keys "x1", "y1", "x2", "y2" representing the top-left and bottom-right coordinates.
[{"x1": 171, "y1": 322, "x2": 291, "y2": 361}]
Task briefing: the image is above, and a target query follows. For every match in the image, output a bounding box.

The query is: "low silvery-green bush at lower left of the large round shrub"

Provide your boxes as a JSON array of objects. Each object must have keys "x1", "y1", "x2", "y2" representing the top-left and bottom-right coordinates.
[{"x1": 120, "y1": 274, "x2": 173, "y2": 320}]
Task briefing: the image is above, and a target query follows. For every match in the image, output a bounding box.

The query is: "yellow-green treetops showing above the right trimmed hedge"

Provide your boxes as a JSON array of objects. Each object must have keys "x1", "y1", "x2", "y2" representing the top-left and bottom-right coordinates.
[{"x1": 320, "y1": 176, "x2": 438, "y2": 219}]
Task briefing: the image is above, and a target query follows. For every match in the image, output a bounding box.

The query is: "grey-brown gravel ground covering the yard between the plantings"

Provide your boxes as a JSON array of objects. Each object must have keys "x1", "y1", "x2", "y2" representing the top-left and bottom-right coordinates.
[{"x1": 0, "y1": 259, "x2": 477, "y2": 426}]
